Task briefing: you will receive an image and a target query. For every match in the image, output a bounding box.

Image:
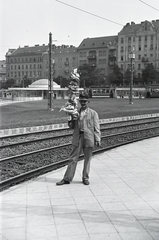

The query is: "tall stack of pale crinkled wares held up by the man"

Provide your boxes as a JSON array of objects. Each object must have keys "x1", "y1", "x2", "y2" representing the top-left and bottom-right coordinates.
[{"x1": 60, "y1": 68, "x2": 80, "y2": 119}]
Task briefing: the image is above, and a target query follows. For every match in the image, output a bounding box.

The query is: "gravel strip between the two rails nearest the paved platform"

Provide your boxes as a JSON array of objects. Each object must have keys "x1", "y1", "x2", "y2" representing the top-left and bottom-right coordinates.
[{"x1": 1, "y1": 125, "x2": 159, "y2": 181}]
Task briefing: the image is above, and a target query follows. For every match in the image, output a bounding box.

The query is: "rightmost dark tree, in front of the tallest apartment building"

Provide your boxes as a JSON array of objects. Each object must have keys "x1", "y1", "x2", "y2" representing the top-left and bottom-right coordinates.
[{"x1": 142, "y1": 63, "x2": 157, "y2": 84}]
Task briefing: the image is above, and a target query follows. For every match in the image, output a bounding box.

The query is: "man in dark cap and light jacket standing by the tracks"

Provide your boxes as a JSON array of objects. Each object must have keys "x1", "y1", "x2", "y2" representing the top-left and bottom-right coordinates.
[{"x1": 56, "y1": 92, "x2": 101, "y2": 186}]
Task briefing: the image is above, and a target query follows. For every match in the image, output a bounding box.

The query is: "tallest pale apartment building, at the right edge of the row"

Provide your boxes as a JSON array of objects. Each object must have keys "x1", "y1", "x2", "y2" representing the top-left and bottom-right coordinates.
[{"x1": 117, "y1": 20, "x2": 159, "y2": 82}]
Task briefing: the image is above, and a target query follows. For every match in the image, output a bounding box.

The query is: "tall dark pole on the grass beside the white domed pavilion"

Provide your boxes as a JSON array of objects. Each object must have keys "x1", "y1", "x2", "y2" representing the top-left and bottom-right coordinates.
[{"x1": 48, "y1": 33, "x2": 54, "y2": 111}]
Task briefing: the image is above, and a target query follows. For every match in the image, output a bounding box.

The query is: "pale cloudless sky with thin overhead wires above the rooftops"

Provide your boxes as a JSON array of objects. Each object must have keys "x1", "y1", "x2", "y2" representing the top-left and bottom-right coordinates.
[{"x1": 0, "y1": 0, "x2": 159, "y2": 60}]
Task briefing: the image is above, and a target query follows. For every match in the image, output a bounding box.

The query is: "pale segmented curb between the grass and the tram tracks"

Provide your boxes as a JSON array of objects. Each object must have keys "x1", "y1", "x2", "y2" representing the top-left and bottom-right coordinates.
[{"x1": 0, "y1": 113, "x2": 159, "y2": 137}]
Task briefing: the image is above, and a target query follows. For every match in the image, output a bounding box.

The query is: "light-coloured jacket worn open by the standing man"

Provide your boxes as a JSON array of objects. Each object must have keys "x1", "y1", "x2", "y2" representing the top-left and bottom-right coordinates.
[{"x1": 68, "y1": 108, "x2": 101, "y2": 147}]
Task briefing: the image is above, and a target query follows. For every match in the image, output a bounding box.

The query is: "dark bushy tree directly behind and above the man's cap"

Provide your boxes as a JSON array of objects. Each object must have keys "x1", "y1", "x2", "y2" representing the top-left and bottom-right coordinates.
[{"x1": 78, "y1": 64, "x2": 101, "y2": 87}]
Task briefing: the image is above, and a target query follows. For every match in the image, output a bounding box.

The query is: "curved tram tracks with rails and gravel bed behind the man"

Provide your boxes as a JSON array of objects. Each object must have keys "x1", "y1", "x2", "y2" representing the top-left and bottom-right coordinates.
[{"x1": 0, "y1": 117, "x2": 159, "y2": 191}]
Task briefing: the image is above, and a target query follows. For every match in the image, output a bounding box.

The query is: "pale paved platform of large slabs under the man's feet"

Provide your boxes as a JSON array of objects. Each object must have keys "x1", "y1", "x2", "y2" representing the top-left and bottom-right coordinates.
[{"x1": 0, "y1": 137, "x2": 159, "y2": 240}]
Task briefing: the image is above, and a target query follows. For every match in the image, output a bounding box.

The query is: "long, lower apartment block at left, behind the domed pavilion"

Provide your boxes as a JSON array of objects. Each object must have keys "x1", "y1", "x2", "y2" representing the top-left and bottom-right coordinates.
[{"x1": 6, "y1": 44, "x2": 77, "y2": 86}]
